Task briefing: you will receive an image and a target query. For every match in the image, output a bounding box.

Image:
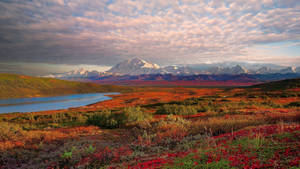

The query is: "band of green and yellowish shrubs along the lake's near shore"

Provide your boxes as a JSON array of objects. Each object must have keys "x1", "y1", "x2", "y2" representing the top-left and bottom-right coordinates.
[{"x1": 0, "y1": 107, "x2": 152, "y2": 130}]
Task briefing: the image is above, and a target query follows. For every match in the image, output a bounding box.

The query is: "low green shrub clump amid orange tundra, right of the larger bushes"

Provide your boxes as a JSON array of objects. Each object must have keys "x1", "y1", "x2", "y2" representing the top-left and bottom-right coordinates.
[{"x1": 156, "y1": 104, "x2": 197, "y2": 115}]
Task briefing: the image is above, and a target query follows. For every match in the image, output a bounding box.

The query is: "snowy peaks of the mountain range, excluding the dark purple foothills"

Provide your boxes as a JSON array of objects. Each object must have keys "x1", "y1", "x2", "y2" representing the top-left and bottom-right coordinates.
[{"x1": 46, "y1": 58, "x2": 300, "y2": 79}]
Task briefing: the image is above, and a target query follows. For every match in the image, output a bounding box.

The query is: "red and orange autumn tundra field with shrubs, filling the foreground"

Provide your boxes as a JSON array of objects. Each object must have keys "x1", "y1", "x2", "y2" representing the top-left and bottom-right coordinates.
[{"x1": 0, "y1": 79, "x2": 300, "y2": 169}]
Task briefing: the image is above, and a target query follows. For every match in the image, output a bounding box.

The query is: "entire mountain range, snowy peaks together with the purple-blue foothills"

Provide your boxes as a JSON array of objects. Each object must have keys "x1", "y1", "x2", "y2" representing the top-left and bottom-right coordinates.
[{"x1": 46, "y1": 58, "x2": 300, "y2": 85}]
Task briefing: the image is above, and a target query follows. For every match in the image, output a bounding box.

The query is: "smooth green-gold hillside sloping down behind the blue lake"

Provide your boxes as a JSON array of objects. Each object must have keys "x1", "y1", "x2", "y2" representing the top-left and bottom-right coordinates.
[{"x1": 0, "y1": 73, "x2": 132, "y2": 99}]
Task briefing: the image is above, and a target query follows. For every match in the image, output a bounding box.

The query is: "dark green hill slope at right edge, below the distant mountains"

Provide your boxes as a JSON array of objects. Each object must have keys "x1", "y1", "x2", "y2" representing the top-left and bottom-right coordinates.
[{"x1": 250, "y1": 78, "x2": 300, "y2": 91}]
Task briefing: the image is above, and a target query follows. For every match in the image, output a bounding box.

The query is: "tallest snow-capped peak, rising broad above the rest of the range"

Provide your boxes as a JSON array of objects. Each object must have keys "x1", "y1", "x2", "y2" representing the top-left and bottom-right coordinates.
[{"x1": 107, "y1": 58, "x2": 161, "y2": 75}]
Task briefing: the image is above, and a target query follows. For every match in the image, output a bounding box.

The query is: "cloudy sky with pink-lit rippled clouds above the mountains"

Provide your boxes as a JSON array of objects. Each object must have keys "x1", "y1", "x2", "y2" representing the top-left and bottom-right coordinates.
[{"x1": 0, "y1": 0, "x2": 300, "y2": 74}]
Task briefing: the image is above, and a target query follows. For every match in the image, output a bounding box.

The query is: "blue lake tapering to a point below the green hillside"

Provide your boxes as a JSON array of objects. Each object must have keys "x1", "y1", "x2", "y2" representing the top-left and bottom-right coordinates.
[{"x1": 0, "y1": 93, "x2": 119, "y2": 114}]
